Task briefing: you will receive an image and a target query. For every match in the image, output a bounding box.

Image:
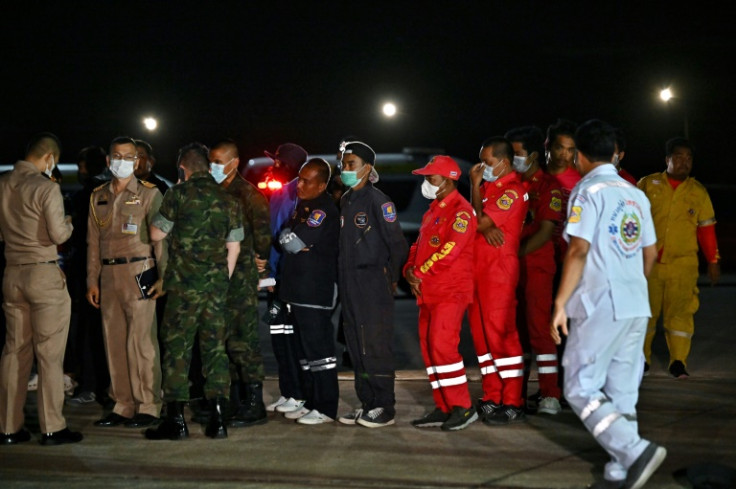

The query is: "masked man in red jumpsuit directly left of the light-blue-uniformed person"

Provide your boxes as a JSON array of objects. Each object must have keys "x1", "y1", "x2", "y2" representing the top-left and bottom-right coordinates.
[{"x1": 506, "y1": 126, "x2": 562, "y2": 415}]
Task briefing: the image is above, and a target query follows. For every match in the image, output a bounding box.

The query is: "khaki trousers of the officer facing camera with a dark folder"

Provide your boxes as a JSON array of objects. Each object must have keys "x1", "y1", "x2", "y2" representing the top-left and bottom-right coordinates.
[{"x1": 100, "y1": 261, "x2": 161, "y2": 418}]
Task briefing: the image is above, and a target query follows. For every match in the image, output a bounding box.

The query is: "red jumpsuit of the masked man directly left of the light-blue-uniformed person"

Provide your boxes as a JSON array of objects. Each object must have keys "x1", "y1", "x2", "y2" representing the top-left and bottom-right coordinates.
[{"x1": 517, "y1": 169, "x2": 562, "y2": 399}]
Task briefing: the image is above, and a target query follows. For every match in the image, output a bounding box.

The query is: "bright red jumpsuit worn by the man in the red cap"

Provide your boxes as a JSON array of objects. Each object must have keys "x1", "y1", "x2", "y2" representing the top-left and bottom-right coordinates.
[{"x1": 404, "y1": 190, "x2": 477, "y2": 413}]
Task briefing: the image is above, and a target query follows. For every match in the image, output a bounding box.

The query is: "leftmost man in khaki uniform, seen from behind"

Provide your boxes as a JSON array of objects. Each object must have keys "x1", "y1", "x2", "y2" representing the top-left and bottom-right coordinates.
[{"x1": 0, "y1": 133, "x2": 82, "y2": 445}]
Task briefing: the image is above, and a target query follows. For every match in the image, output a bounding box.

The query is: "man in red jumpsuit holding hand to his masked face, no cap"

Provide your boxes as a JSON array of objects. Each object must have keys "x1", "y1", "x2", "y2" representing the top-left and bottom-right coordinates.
[{"x1": 468, "y1": 137, "x2": 529, "y2": 425}]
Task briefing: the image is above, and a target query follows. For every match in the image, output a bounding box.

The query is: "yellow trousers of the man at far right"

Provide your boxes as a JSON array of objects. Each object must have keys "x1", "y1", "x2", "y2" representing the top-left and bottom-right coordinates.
[{"x1": 644, "y1": 263, "x2": 700, "y2": 366}]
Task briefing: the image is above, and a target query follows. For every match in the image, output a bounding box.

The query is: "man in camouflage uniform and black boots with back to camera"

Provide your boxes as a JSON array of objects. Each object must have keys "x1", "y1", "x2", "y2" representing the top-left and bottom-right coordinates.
[{"x1": 146, "y1": 143, "x2": 243, "y2": 440}]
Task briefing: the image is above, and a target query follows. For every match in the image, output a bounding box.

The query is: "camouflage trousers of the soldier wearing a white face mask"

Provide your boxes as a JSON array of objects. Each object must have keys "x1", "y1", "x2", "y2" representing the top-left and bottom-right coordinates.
[{"x1": 230, "y1": 263, "x2": 265, "y2": 383}]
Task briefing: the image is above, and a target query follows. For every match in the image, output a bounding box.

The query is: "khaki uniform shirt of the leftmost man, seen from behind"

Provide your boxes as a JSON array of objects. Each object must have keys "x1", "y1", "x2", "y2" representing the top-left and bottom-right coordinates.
[{"x1": 0, "y1": 160, "x2": 72, "y2": 265}]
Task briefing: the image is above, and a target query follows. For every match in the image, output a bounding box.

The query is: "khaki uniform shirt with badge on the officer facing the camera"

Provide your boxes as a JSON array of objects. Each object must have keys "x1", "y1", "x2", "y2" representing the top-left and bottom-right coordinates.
[{"x1": 87, "y1": 177, "x2": 167, "y2": 288}]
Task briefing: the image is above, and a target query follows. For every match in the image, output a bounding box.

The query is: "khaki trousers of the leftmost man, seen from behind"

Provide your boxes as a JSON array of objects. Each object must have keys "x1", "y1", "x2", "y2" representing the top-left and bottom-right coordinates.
[{"x1": 0, "y1": 263, "x2": 71, "y2": 433}]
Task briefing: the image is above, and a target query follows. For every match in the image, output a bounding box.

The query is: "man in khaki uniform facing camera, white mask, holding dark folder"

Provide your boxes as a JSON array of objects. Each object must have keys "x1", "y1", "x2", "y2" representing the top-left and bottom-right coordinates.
[{"x1": 87, "y1": 137, "x2": 165, "y2": 428}]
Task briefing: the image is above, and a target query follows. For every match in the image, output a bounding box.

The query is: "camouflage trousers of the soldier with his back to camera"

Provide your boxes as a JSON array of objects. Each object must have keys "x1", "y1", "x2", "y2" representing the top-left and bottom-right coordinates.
[{"x1": 161, "y1": 282, "x2": 230, "y2": 402}]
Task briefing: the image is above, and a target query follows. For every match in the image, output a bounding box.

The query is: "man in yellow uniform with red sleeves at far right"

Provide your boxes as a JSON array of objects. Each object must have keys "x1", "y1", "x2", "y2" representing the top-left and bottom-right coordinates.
[{"x1": 637, "y1": 138, "x2": 721, "y2": 379}]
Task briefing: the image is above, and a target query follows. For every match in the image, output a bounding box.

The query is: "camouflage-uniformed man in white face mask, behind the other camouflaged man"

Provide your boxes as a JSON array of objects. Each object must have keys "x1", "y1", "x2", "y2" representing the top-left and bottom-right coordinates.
[{"x1": 209, "y1": 140, "x2": 271, "y2": 427}]
